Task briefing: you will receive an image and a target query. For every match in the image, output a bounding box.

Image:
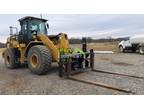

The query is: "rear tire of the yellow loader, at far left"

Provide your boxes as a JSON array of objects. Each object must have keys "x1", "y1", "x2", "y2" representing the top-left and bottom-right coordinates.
[{"x1": 3, "y1": 48, "x2": 19, "y2": 69}]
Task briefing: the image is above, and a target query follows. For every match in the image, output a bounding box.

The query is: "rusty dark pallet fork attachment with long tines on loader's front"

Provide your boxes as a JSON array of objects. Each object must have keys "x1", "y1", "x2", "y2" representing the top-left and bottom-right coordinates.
[{"x1": 59, "y1": 39, "x2": 134, "y2": 94}]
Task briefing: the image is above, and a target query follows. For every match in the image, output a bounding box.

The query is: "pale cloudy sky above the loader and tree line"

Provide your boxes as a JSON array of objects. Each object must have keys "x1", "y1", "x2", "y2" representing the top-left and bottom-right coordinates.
[{"x1": 0, "y1": 14, "x2": 144, "y2": 42}]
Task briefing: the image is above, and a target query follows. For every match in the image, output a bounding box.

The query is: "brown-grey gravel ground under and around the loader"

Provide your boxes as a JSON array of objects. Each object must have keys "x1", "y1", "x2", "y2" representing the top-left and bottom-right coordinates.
[{"x1": 0, "y1": 53, "x2": 144, "y2": 95}]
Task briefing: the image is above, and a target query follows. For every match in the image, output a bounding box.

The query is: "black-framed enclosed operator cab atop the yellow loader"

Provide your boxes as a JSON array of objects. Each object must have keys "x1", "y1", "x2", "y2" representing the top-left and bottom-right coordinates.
[{"x1": 19, "y1": 16, "x2": 48, "y2": 44}]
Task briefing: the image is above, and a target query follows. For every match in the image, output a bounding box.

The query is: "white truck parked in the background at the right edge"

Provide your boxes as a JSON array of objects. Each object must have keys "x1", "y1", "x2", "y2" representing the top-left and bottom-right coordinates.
[{"x1": 119, "y1": 34, "x2": 144, "y2": 54}]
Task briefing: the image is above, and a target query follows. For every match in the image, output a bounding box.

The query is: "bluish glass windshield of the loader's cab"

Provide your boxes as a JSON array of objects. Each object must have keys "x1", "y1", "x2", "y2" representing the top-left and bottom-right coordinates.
[{"x1": 30, "y1": 20, "x2": 47, "y2": 34}]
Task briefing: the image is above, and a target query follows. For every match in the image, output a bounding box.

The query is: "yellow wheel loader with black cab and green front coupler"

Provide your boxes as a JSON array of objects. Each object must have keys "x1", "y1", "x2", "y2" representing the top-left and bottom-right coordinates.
[{"x1": 3, "y1": 16, "x2": 92, "y2": 75}]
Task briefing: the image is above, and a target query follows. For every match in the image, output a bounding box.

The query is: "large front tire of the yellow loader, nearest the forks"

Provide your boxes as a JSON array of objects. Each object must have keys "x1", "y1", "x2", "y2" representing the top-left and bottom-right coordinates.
[{"x1": 28, "y1": 45, "x2": 52, "y2": 75}]
